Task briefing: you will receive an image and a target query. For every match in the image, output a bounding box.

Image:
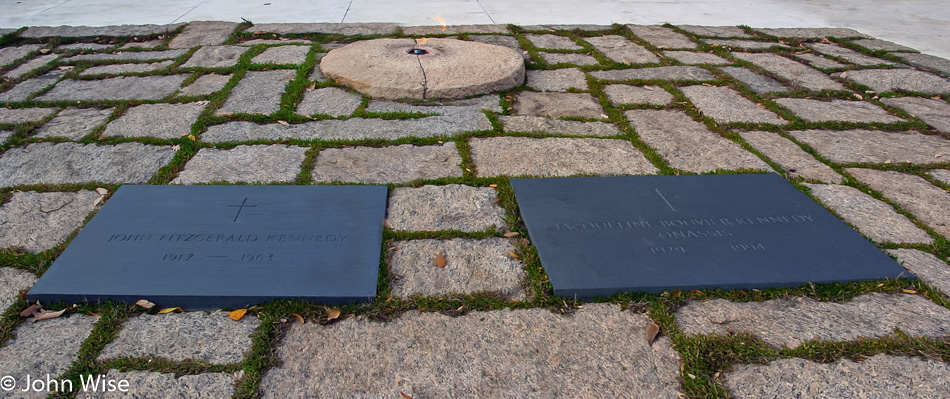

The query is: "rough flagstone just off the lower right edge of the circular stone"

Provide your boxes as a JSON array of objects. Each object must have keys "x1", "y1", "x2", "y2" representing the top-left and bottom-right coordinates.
[{"x1": 515, "y1": 91, "x2": 606, "y2": 118}]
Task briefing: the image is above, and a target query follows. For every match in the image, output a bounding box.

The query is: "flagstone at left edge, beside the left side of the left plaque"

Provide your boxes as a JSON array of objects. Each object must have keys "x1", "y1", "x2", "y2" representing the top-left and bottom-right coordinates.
[{"x1": 0, "y1": 190, "x2": 99, "y2": 253}]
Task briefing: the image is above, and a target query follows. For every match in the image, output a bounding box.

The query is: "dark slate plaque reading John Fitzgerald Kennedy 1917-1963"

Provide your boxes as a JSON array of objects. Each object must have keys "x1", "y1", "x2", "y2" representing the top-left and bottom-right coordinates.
[{"x1": 27, "y1": 186, "x2": 387, "y2": 309}]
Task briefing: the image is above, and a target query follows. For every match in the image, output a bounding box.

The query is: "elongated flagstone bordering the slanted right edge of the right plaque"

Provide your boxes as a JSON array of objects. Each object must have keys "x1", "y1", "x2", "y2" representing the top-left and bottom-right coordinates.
[{"x1": 805, "y1": 183, "x2": 933, "y2": 244}]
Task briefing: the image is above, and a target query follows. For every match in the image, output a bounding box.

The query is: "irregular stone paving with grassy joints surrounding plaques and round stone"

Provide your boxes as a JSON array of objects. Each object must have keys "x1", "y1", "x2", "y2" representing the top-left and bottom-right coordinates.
[{"x1": 0, "y1": 22, "x2": 950, "y2": 398}]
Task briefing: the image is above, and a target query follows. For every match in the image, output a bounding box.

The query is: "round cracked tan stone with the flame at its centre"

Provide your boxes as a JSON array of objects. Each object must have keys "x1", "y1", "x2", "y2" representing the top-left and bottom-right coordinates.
[{"x1": 320, "y1": 39, "x2": 524, "y2": 100}]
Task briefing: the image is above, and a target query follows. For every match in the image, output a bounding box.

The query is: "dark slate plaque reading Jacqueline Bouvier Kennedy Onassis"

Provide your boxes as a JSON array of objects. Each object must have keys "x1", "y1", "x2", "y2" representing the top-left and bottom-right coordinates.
[{"x1": 511, "y1": 173, "x2": 914, "y2": 299}]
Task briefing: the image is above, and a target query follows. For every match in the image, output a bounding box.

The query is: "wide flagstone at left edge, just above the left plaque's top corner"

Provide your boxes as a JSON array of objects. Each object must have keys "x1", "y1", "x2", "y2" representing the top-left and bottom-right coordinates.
[{"x1": 0, "y1": 143, "x2": 175, "y2": 187}]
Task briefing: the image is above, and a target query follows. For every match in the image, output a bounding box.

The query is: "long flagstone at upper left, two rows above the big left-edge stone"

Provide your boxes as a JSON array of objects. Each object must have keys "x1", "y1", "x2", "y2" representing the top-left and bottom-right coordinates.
[{"x1": 36, "y1": 75, "x2": 188, "y2": 101}]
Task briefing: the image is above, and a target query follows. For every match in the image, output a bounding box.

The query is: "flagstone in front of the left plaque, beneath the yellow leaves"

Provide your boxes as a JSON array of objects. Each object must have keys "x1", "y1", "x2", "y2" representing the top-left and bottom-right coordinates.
[{"x1": 98, "y1": 312, "x2": 261, "y2": 364}]
